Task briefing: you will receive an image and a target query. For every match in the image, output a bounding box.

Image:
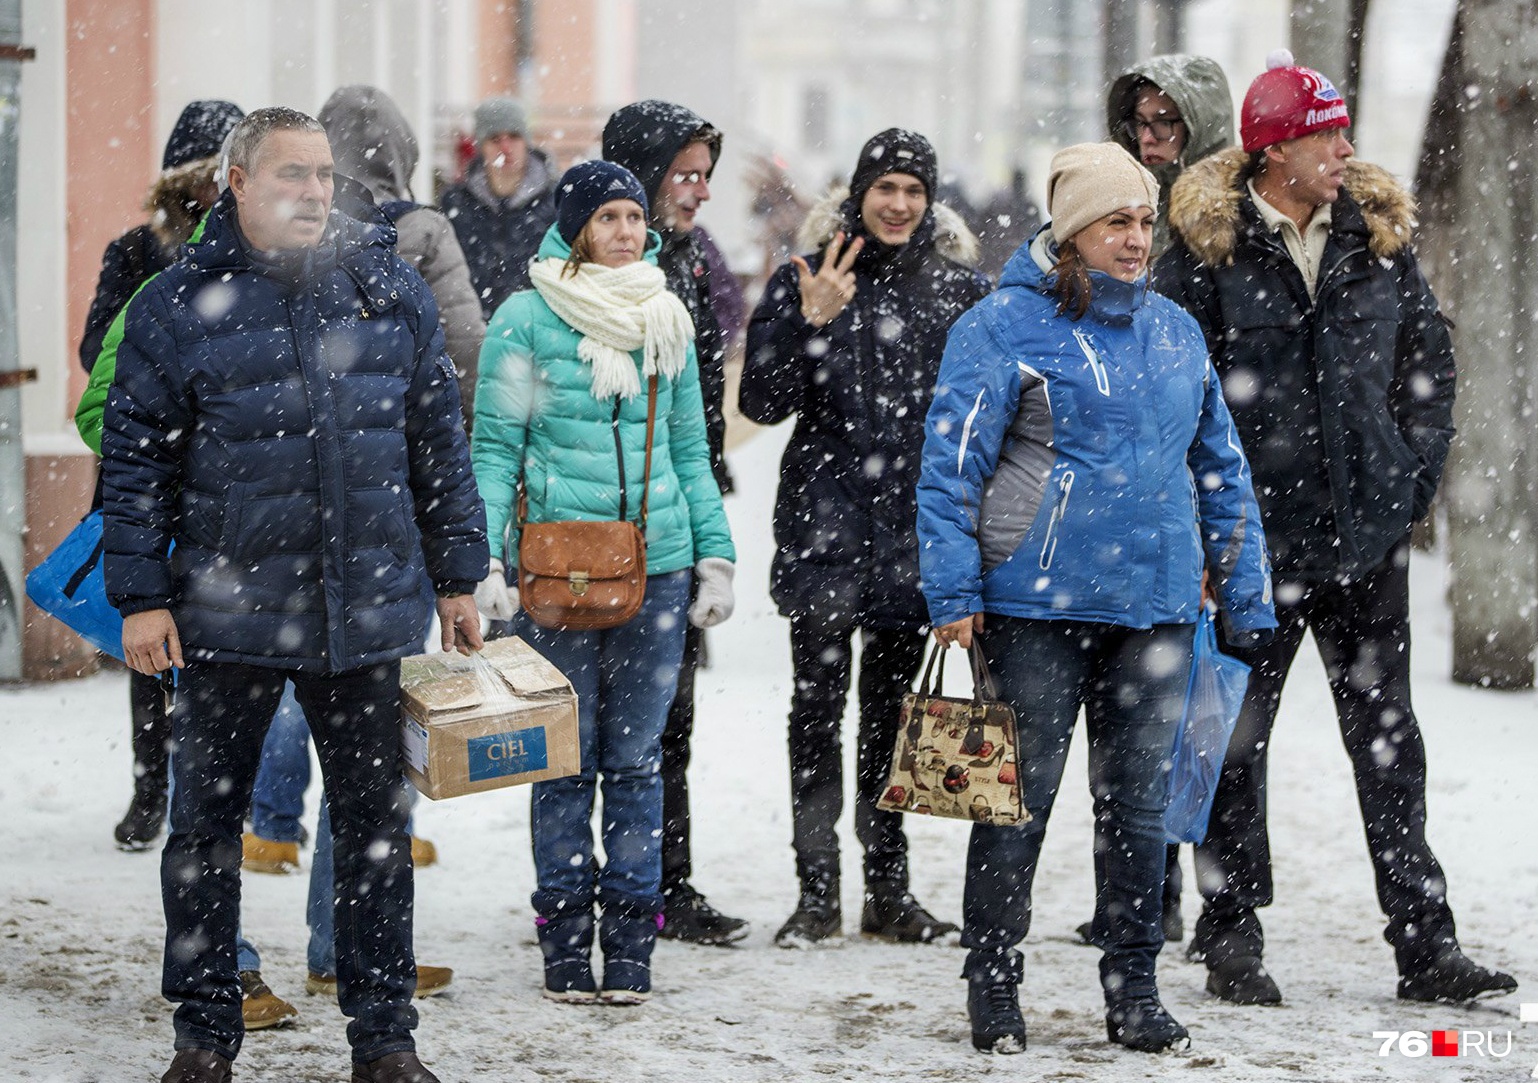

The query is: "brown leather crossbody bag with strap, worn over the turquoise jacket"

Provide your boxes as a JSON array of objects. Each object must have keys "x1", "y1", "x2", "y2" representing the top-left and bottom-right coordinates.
[{"x1": 518, "y1": 375, "x2": 657, "y2": 632}]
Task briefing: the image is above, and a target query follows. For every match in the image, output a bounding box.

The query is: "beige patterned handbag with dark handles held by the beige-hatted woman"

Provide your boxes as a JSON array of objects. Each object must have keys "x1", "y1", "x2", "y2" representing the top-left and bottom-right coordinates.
[{"x1": 877, "y1": 637, "x2": 1030, "y2": 825}]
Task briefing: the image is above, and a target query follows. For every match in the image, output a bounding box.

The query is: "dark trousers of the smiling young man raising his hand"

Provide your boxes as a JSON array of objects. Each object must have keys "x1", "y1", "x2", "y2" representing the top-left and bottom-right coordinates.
[{"x1": 791, "y1": 620, "x2": 924, "y2": 889}]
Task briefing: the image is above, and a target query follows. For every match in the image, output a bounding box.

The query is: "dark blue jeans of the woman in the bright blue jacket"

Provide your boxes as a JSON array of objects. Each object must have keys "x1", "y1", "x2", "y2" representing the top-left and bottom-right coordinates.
[{"x1": 961, "y1": 614, "x2": 1192, "y2": 1003}]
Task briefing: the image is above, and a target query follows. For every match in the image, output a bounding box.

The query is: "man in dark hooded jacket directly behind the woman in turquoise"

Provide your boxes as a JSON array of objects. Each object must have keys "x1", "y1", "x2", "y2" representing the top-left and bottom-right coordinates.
[{"x1": 603, "y1": 100, "x2": 749, "y2": 945}]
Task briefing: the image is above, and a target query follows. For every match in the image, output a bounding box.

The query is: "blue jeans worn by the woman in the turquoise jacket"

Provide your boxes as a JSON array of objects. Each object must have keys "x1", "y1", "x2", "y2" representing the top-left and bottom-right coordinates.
[{"x1": 514, "y1": 571, "x2": 692, "y2": 912}]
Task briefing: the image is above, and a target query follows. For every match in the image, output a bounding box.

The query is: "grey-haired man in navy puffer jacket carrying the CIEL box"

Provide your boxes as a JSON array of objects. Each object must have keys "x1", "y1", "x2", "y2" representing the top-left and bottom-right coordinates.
[{"x1": 103, "y1": 108, "x2": 488, "y2": 1083}]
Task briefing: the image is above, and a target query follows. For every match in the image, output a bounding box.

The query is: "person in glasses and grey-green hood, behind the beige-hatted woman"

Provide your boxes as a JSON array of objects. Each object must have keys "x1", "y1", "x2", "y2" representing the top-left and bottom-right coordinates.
[{"x1": 1106, "y1": 54, "x2": 1233, "y2": 258}]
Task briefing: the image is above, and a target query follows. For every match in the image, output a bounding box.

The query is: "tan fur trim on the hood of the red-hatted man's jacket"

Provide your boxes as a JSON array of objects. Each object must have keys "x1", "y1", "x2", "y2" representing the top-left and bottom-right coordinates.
[{"x1": 1169, "y1": 148, "x2": 1415, "y2": 266}]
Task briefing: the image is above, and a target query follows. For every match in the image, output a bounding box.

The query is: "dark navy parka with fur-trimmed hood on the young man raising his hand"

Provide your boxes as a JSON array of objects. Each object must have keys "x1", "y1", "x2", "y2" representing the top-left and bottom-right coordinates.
[{"x1": 740, "y1": 189, "x2": 992, "y2": 628}]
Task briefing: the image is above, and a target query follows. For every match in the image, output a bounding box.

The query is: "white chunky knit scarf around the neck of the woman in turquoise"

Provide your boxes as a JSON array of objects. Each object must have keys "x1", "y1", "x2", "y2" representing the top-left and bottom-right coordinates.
[{"x1": 529, "y1": 257, "x2": 694, "y2": 398}]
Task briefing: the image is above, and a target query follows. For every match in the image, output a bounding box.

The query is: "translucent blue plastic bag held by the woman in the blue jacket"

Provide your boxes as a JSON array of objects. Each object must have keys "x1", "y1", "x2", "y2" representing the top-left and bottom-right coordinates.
[{"x1": 1164, "y1": 606, "x2": 1250, "y2": 843}]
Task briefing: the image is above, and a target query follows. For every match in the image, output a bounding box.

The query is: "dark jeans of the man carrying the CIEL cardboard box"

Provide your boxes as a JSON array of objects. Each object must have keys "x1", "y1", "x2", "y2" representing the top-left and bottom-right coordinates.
[{"x1": 160, "y1": 661, "x2": 417, "y2": 1061}]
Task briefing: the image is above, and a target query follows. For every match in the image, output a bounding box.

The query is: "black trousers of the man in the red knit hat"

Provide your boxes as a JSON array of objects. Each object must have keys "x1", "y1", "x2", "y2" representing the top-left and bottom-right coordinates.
[{"x1": 1195, "y1": 540, "x2": 1456, "y2": 974}]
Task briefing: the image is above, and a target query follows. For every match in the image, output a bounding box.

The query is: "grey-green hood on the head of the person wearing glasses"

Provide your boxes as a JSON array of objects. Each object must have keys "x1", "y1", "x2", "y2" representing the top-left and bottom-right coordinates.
[{"x1": 1106, "y1": 52, "x2": 1235, "y2": 179}]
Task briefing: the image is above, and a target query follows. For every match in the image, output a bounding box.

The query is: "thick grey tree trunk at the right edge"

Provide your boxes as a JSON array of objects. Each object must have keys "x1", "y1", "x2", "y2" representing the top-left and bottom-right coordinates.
[{"x1": 1418, "y1": 0, "x2": 1538, "y2": 688}]
